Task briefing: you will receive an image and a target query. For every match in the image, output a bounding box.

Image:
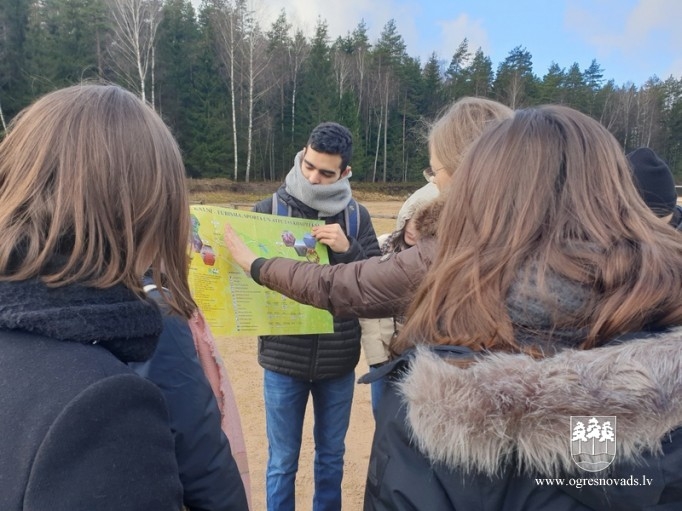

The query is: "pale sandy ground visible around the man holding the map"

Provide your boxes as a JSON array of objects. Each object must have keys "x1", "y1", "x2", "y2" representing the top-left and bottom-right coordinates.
[{"x1": 217, "y1": 201, "x2": 402, "y2": 511}]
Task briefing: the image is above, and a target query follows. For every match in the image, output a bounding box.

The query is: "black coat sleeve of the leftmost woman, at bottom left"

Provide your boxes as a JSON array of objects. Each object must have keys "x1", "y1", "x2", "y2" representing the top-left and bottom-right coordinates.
[{"x1": 24, "y1": 374, "x2": 182, "y2": 511}]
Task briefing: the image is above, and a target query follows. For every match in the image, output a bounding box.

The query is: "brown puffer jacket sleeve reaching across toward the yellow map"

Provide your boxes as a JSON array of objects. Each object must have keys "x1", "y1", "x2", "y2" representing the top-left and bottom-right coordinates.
[{"x1": 251, "y1": 238, "x2": 436, "y2": 318}]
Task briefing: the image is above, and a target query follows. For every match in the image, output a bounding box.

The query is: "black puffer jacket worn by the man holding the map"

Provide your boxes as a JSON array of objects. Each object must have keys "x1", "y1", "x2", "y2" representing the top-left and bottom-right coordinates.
[{"x1": 253, "y1": 185, "x2": 381, "y2": 380}]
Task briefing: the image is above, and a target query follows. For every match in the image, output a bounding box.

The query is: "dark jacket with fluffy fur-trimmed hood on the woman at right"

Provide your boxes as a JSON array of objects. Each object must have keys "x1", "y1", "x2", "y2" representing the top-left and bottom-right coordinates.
[{"x1": 364, "y1": 329, "x2": 682, "y2": 511}]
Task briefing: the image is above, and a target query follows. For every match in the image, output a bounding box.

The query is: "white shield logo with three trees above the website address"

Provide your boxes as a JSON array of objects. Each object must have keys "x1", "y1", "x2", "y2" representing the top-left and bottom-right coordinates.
[{"x1": 571, "y1": 415, "x2": 616, "y2": 472}]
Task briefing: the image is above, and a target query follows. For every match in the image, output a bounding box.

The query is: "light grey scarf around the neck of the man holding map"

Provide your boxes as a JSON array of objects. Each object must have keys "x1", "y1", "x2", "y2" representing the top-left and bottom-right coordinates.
[{"x1": 284, "y1": 151, "x2": 352, "y2": 218}]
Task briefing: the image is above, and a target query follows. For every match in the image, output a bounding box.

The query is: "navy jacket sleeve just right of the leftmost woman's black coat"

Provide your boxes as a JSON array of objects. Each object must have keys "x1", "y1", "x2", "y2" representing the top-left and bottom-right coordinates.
[{"x1": 131, "y1": 315, "x2": 247, "y2": 511}]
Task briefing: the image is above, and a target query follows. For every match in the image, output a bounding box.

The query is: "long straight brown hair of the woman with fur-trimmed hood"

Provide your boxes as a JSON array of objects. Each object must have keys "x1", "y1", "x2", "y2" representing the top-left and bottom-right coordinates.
[{"x1": 393, "y1": 106, "x2": 682, "y2": 355}]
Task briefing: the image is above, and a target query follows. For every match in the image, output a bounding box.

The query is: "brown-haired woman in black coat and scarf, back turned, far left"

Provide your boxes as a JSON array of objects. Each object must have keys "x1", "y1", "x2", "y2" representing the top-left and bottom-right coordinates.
[{"x1": 0, "y1": 84, "x2": 196, "y2": 511}]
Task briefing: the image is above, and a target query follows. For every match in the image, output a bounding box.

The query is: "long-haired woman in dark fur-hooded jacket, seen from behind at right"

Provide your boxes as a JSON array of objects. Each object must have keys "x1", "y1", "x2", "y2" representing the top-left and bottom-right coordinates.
[{"x1": 364, "y1": 106, "x2": 682, "y2": 511}]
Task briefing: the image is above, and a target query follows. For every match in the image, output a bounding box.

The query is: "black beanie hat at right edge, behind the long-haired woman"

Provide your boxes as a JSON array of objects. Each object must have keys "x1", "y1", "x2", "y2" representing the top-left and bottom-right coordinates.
[{"x1": 627, "y1": 147, "x2": 677, "y2": 218}]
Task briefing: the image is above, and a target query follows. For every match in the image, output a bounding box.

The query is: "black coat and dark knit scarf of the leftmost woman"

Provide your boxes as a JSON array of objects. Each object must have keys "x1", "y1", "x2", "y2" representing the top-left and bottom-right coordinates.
[{"x1": 0, "y1": 282, "x2": 182, "y2": 511}]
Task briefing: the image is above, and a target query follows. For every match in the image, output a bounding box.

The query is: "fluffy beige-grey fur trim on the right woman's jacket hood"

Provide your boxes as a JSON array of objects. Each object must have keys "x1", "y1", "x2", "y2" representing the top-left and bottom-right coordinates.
[{"x1": 399, "y1": 328, "x2": 682, "y2": 476}]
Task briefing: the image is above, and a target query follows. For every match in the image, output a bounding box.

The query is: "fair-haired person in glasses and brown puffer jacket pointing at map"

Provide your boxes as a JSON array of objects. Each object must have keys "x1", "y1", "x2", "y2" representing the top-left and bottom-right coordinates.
[{"x1": 224, "y1": 97, "x2": 513, "y2": 340}]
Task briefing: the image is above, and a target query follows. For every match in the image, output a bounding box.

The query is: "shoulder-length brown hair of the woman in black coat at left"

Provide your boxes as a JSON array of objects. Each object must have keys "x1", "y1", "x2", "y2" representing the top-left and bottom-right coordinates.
[{"x1": 0, "y1": 84, "x2": 196, "y2": 317}]
